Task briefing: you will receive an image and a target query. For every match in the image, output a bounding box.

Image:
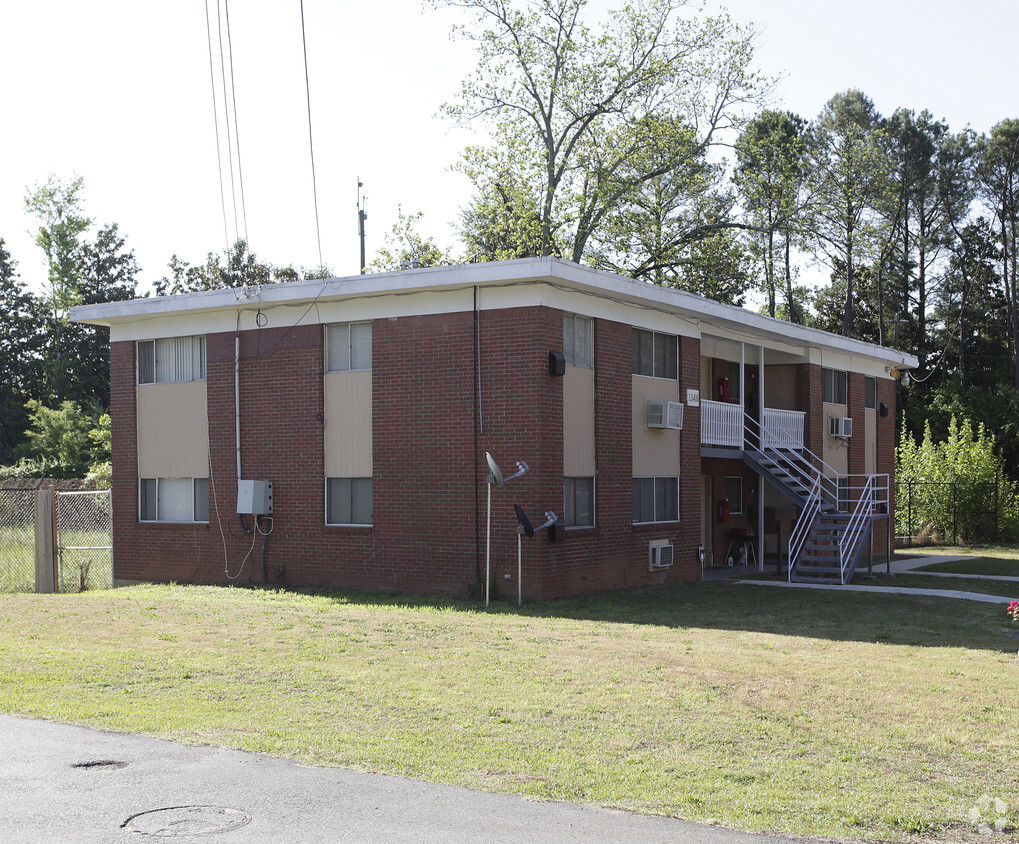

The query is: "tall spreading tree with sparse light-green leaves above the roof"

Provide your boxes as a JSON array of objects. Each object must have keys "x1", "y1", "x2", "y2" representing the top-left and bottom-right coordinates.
[{"x1": 444, "y1": 0, "x2": 761, "y2": 265}]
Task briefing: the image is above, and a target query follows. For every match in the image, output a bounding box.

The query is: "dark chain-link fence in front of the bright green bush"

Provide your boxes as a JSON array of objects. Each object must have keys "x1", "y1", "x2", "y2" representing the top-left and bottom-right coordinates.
[{"x1": 896, "y1": 480, "x2": 1002, "y2": 547}]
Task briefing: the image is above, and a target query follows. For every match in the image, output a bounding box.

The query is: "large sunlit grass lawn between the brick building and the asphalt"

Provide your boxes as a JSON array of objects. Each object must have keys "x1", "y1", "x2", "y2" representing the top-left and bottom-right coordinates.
[{"x1": 0, "y1": 583, "x2": 1019, "y2": 841}]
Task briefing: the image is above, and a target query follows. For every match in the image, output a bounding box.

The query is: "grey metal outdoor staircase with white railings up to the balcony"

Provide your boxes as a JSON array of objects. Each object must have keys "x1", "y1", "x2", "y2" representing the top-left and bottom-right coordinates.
[{"x1": 743, "y1": 416, "x2": 889, "y2": 585}]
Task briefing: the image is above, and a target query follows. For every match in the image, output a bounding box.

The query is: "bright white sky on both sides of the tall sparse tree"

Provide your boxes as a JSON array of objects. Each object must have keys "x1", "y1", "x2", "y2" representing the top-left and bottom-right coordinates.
[{"x1": 0, "y1": 0, "x2": 1019, "y2": 297}]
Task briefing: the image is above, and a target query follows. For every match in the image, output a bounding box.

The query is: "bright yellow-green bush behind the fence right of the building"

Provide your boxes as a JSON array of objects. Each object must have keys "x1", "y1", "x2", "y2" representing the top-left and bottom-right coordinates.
[{"x1": 896, "y1": 416, "x2": 1019, "y2": 542}]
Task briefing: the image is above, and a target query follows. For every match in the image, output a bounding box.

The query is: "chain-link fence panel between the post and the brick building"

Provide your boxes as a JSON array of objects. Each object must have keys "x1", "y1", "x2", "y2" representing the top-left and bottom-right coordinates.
[{"x1": 56, "y1": 489, "x2": 113, "y2": 592}]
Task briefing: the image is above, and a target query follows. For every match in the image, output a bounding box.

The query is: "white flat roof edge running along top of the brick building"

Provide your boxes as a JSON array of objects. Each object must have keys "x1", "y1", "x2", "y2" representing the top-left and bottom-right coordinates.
[{"x1": 69, "y1": 257, "x2": 918, "y2": 369}]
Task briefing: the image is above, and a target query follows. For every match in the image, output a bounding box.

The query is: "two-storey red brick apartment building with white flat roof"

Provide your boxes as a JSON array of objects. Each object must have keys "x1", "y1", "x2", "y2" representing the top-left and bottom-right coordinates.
[{"x1": 71, "y1": 259, "x2": 916, "y2": 599}]
